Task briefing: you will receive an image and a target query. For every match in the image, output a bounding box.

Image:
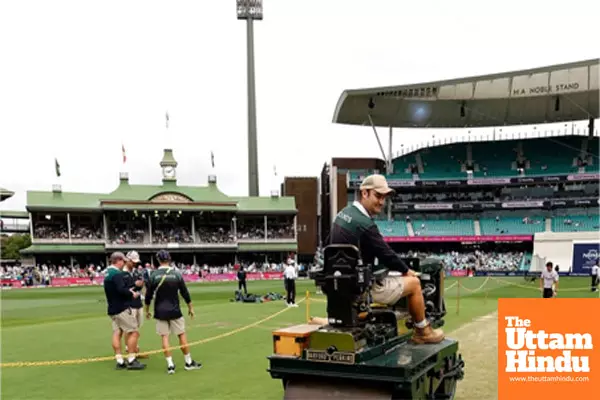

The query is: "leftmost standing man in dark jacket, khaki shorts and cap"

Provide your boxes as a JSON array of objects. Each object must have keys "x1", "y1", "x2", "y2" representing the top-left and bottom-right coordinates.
[{"x1": 104, "y1": 252, "x2": 146, "y2": 370}]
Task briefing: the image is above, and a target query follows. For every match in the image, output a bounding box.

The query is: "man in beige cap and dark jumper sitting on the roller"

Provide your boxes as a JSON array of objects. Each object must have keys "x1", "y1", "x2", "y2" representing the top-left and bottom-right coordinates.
[{"x1": 330, "y1": 175, "x2": 444, "y2": 344}]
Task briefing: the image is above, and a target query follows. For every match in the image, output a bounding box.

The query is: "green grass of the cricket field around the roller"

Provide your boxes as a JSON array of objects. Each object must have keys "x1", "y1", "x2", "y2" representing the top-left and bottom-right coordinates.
[{"x1": 1, "y1": 277, "x2": 597, "y2": 399}]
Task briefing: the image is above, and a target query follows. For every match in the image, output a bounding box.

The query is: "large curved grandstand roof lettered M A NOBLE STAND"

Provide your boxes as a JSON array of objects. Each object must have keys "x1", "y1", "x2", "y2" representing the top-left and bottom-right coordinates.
[{"x1": 333, "y1": 59, "x2": 600, "y2": 128}]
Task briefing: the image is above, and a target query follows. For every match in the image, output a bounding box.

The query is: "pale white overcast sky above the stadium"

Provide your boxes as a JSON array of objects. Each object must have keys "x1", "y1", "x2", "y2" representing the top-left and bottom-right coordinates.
[{"x1": 0, "y1": 0, "x2": 599, "y2": 210}]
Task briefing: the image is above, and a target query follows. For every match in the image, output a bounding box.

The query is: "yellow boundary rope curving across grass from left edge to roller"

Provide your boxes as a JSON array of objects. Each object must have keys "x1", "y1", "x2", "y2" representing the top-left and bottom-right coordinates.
[{"x1": 0, "y1": 298, "x2": 306, "y2": 368}]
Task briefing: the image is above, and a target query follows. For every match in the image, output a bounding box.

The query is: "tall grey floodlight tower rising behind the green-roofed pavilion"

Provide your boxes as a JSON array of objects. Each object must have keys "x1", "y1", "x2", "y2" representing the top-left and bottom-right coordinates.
[{"x1": 236, "y1": 0, "x2": 263, "y2": 196}]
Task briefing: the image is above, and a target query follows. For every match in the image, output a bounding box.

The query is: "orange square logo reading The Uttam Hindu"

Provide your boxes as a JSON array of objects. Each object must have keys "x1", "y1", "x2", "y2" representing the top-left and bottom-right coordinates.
[{"x1": 496, "y1": 298, "x2": 600, "y2": 400}]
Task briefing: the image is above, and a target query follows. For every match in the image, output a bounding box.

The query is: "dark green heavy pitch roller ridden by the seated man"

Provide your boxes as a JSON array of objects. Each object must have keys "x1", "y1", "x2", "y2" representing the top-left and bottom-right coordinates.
[{"x1": 268, "y1": 245, "x2": 464, "y2": 399}]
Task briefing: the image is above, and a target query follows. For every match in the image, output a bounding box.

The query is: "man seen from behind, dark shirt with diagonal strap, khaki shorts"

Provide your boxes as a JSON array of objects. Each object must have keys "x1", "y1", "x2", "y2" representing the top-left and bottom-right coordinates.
[{"x1": 144, "y1": 250, "x2": 202, "y2": 374}]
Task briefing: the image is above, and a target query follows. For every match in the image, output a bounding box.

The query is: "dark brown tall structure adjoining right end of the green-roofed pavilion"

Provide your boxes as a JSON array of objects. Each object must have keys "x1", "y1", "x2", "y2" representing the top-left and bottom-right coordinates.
[{"x1": 282, "y1": 177, "x2": 319, "y2": 257}]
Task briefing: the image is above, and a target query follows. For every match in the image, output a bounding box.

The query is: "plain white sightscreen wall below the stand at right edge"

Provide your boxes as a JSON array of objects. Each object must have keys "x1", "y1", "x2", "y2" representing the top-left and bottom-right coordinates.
[{"x1": 531, "y1": 231, "x2": 599, "y2": 271}]
